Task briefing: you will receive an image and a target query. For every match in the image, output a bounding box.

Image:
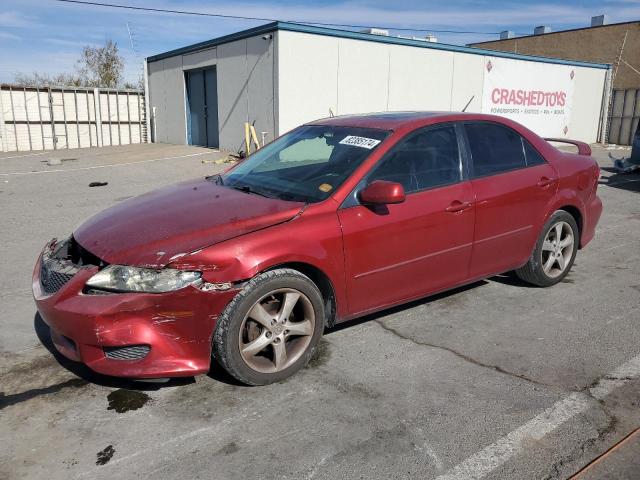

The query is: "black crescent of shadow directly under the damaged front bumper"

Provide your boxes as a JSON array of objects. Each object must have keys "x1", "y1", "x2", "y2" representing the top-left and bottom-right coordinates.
[{"x1": 33, "y1": 313, "x2": 195, "y2": 391}]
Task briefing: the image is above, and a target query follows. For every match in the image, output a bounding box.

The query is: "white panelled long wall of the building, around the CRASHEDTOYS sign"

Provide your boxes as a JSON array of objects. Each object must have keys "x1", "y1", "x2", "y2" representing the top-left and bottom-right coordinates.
[{"x1": 277, "y1": 31, "x2": 606, "y2": 142}]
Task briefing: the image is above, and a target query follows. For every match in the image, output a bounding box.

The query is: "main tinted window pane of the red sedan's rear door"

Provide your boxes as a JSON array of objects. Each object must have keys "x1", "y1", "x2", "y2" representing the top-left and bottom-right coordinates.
[{"x1": 465, "y1": 122, "x2": 527, "y2": 177}]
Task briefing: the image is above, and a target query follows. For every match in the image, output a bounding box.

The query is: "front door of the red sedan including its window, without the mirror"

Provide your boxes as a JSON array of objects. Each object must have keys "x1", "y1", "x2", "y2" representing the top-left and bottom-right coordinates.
[{"x1": 338, "y1": 124, "x2": 474, "y2": 314}]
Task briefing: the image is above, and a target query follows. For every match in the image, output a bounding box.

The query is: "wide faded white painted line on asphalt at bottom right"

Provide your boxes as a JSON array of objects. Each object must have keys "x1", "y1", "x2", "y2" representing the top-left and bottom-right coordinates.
[{"x1": 436, "y1": 355, "x2": 640, "y2": 480}]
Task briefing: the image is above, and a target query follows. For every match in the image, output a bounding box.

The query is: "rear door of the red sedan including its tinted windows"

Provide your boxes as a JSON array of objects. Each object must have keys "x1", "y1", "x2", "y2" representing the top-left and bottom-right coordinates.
[{"x1": 464, "y1": 122, "x2": 558, "y2": 278}]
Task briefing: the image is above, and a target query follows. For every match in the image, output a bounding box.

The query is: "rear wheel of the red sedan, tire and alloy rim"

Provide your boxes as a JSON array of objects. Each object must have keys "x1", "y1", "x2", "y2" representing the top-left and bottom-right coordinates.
[{"x1": 516, "y1": 210, "x2": 580, "y2": 287}]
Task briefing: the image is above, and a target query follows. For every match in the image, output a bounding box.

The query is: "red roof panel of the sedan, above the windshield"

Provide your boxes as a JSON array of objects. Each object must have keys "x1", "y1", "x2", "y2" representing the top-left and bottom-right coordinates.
[{"x1": 307, "y1": 111, "x2": 511, "y2": 130}]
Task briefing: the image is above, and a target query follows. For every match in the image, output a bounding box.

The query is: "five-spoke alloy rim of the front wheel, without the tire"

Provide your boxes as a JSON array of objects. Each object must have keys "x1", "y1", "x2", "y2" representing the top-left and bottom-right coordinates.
[{"x1": 239, "y1": 288, "x2": 316, "y2": 373}]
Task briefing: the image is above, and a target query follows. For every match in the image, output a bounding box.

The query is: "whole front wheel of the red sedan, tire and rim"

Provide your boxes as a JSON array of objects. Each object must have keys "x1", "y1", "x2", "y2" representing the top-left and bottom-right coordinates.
[{"x1": 212, "y1": 268, "x2": 324, "y2": 385}]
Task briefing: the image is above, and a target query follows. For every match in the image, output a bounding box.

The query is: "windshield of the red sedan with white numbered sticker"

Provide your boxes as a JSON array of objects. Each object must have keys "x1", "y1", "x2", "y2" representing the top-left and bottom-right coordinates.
[{"x1": 218, "y1": 125, "x2": 390, "y2": 203}]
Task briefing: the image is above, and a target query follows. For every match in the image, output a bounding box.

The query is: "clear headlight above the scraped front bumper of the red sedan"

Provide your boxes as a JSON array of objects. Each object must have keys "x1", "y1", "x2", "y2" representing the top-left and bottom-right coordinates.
[{"x1": 87, "y1": 265, "x2": 201, "y2": 293}]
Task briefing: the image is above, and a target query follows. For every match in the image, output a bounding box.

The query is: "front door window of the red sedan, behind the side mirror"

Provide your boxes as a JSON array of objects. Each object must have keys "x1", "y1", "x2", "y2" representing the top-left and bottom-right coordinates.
[{"x1": 369, "y1": 125, "x2": 461, "y2": 193}]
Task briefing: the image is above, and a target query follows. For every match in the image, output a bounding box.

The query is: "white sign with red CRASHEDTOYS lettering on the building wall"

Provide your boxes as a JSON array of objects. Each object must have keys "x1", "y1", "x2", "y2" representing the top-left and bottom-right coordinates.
[{"x1": 482, "y1": 57, "x2": 576, "y2": 137}]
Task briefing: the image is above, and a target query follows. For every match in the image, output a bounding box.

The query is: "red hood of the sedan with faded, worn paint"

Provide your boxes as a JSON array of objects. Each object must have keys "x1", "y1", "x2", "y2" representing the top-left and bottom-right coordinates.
[{"x1": 73, "y1": 179, "x2": 304, "y2": 268}]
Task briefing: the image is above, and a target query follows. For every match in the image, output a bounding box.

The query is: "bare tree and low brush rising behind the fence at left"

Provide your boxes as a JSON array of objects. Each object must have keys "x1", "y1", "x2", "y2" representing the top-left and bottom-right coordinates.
[{"x1": 14, "y1": 40, "x2": 129, "y2": 88}]
